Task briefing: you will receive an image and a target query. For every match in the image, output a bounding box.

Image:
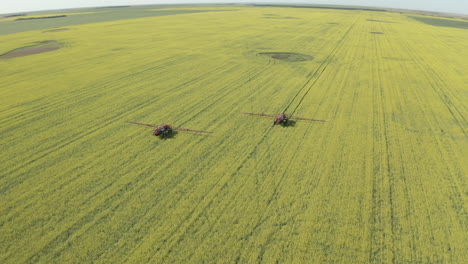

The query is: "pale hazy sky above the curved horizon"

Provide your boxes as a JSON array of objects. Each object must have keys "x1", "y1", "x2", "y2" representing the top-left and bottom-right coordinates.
[{"x1": 0, "y1": 0, "x2": 468, "y2": 15}]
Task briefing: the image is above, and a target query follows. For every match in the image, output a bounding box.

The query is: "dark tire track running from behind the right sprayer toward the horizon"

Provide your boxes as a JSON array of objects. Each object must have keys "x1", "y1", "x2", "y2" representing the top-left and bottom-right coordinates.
[{"x1": 283, "y1": 16, "x2": 360, "y2": 116}]
